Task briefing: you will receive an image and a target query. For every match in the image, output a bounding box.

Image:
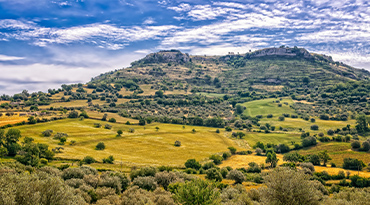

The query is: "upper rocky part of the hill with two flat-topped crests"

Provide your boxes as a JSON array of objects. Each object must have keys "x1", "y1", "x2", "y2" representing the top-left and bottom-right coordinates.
[{"x1": 89, "y1": 47, "x2": 370, "y2": 93}]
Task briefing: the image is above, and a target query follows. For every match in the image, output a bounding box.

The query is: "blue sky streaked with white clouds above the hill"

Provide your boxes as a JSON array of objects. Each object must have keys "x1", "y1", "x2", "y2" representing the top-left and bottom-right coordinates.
[{"x1": 0, "y1": 0, "x2": 370, "y2": 94}]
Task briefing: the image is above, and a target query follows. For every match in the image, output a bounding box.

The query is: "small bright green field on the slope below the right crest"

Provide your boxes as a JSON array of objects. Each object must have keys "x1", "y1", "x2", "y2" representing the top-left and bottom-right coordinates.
[{"x1": 242, "y1": 98, "x2": 294, "y2": 117}]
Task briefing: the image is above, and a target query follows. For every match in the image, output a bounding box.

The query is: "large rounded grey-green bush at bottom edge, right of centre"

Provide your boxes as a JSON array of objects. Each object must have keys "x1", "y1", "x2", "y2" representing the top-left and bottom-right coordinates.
[{"x1": 261, "y1": 168, "x2": 323, "y2": 205}]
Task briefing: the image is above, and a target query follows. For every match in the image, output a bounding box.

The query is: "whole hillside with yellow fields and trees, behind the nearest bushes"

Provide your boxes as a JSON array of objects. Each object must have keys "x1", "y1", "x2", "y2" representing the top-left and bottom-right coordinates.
[{"x1": 0, "y1": 47, "x2": 370, "y2": 204}]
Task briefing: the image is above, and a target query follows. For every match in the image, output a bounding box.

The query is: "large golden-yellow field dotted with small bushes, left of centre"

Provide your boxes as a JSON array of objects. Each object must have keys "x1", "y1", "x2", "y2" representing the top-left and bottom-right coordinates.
[{"x1": 8, "y1": 119, "x2": 242, "y2": 167}]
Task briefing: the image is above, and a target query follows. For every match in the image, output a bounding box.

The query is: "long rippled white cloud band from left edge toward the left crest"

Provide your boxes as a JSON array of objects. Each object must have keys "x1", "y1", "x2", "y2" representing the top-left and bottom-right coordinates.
[{"x1": 0, "y1": 20, "x2": 178, "y2": 50}]
